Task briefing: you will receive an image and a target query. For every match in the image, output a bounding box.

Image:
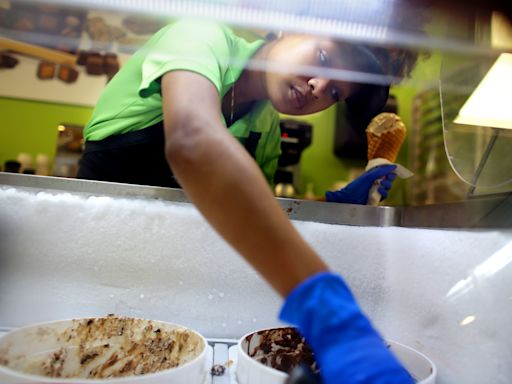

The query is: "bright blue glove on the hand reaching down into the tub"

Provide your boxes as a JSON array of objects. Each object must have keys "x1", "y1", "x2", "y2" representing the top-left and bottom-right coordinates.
[{"x1": 280, "y1": 272, "x2": 414, "y2": 384}]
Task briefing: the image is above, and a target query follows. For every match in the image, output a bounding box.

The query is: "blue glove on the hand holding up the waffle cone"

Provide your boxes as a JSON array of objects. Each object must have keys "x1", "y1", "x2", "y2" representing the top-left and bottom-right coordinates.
[{"x1": 325, "y1": 164, "x2": 396, "y2": 204}]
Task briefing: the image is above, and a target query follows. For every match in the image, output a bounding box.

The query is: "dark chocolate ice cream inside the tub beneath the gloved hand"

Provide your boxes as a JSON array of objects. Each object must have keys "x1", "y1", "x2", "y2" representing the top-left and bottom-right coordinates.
[{"x1": 246, "y1": 327, "x2": 318, "y2": 373}]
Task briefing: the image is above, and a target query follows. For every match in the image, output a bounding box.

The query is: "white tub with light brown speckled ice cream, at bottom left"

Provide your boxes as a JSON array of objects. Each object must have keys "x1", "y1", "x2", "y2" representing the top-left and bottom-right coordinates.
[{"x1": 0, "y1": 316, "x2": 208, "y2": 384}]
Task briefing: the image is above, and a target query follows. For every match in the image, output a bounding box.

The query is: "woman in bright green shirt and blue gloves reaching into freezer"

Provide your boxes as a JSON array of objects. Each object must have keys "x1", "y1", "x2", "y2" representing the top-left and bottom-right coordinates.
[{"x1": 79, "y1": 20, "x2": 420, "y2": 383}]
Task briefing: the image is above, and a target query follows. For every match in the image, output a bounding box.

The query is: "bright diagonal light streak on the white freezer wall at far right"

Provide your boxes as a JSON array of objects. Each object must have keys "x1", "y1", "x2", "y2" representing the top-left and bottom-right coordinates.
[{"x1": 446, "y1": 242, "x2": 512, "y2": 300}]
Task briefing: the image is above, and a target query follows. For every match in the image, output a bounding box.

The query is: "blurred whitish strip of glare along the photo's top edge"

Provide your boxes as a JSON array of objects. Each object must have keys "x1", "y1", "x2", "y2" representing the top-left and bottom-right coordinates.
[{"x1": 47, "y1": 0, "x2": 394, "y2": 41}]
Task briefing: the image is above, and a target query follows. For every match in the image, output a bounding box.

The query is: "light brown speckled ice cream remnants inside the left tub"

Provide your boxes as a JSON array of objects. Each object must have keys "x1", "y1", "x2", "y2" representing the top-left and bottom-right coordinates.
[{"x1": 0, "y1": 316, "x2": 206, "y2": 379}]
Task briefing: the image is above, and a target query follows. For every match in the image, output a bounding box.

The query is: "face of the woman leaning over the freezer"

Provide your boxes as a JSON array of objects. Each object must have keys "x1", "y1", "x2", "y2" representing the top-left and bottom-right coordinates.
[{"x1": 265, "y1": 35, "x2": 352, "y2": 115}]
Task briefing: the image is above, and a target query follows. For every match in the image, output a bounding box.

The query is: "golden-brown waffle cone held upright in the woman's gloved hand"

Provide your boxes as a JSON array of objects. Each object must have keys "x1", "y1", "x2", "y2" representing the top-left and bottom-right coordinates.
[{"x1": 366, "y1": 113, "x2": 406, "y2": 163}]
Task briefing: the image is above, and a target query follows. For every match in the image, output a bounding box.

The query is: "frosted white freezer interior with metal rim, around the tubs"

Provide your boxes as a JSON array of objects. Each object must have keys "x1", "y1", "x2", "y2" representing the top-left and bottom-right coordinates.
[{"x1": 0, "y1": 173, "x2": 512, "y2": 383}]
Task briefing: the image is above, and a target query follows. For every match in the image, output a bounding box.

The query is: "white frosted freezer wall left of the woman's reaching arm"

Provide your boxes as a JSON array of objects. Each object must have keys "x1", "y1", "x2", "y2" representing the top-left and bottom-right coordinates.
[{"x1": 0, "y1": 187, "x2": 280, "y2": 340}]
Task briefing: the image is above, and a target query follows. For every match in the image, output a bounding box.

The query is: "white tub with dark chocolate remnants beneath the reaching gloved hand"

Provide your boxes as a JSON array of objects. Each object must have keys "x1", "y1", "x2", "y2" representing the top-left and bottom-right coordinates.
[{"x1": 236, "y1": 327, "x2": 436, "y2": 384}]
